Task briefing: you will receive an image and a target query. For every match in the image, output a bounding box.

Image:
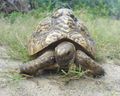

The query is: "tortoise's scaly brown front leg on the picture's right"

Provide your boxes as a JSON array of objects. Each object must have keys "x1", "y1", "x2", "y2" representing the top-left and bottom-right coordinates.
[{"x1": 75, "y1": 50, "x2": 105, "y2": 77}]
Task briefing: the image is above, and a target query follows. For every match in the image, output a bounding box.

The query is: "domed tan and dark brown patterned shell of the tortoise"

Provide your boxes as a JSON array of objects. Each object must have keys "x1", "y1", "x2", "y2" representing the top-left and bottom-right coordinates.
[{"x1": 28, "y1": 8, "x2": 95, "y2": 57}]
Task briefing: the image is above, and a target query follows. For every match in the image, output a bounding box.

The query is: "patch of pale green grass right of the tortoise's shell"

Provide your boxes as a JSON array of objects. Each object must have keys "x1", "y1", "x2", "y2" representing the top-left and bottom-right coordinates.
[{"x1": 87, "y1": 18, "x2": 120, "y2": 59}]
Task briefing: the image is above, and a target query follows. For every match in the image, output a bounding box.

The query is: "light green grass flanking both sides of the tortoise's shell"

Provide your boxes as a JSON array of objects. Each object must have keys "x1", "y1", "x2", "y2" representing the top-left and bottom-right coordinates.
[{"x1": 0, "y1": 11, "x2": 120, "y2": 61}]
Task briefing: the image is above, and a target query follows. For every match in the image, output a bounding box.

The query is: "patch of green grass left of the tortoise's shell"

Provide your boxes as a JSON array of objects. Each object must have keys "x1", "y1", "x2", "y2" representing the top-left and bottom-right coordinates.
[{"x1": 0, "y1": 13, "x2": 49, "y2": 61}]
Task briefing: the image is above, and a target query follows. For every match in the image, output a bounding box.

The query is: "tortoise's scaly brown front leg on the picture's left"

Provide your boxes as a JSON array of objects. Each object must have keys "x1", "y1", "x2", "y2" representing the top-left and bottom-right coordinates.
[{"x1": 20, "y1": 50, "x2": 55, "y2": 75}]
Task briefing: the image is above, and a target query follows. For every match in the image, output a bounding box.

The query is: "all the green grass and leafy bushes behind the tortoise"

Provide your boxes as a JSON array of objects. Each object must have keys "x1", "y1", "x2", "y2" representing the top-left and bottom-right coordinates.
[{"x1": 0, "y1": 0, "x2": 120, "y2": 61}]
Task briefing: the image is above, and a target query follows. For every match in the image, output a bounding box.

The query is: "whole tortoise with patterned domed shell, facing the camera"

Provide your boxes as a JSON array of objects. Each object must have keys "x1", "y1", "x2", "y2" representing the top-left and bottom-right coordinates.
[{"x1": 20, "y1": 8, "x2": 105, "y2": 77}]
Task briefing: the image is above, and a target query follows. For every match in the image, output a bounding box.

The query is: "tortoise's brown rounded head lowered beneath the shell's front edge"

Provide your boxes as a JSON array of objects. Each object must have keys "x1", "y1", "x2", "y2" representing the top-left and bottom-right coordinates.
[{"x1": 55, "y1": 41, "x2": 75, "y2": 68}]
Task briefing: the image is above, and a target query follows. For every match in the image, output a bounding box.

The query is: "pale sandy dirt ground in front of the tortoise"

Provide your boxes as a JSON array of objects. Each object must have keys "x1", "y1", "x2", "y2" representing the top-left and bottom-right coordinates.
[{"x1": 0, "y1": 46, "x2": 120, "y2": 96}]
